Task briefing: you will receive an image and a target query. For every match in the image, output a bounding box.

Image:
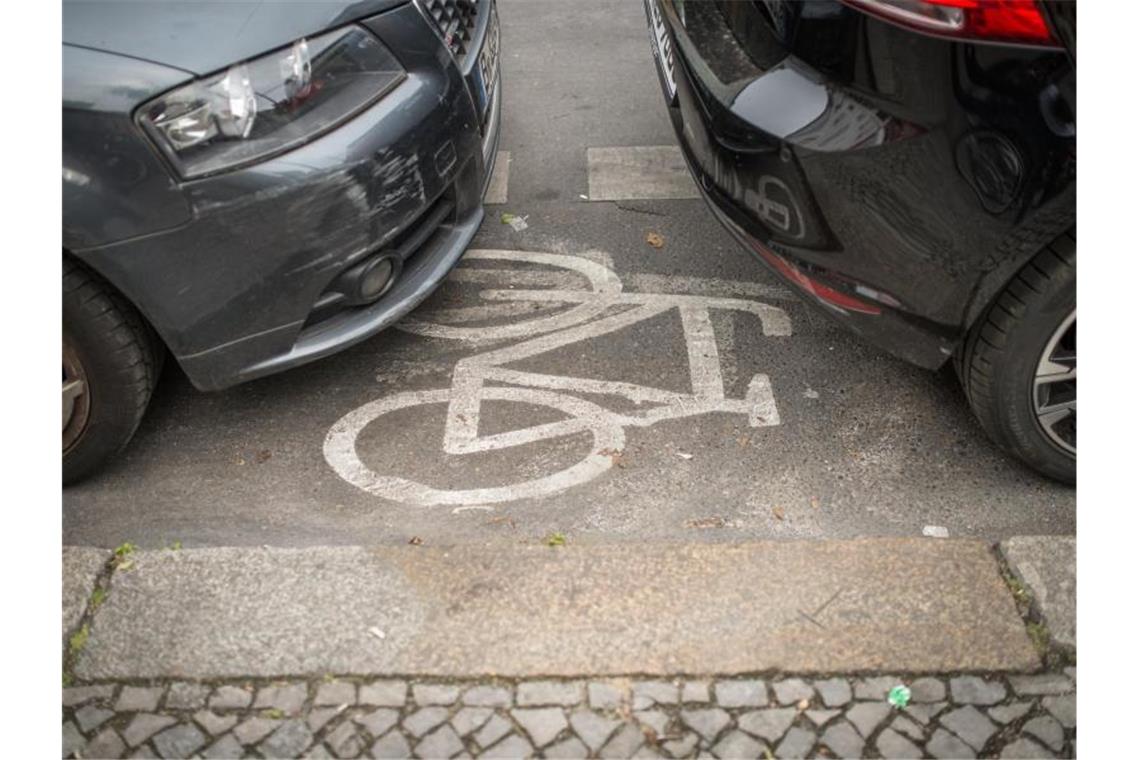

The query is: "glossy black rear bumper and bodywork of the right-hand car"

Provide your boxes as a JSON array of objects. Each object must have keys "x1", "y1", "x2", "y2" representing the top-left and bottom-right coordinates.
[{"x1": 646, "y1": 0, "x2": 1075, "y2": 368}]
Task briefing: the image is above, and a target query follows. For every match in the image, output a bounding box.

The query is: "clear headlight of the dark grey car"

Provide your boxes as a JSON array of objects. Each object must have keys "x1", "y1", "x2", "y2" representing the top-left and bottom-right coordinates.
[{"x1": 138, "y1": 26, "x2": 405, "y2": 179}]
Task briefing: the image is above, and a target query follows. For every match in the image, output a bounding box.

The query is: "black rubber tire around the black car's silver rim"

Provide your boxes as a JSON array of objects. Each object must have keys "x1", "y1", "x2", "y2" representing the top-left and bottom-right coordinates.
[{"x1": 956, "y1": 230, "x2": 1076, "y2": 483}]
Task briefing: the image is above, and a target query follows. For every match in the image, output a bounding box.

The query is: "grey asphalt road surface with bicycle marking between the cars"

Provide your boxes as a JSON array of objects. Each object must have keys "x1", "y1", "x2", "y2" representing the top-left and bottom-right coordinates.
[{"x1": 64, "y1": 0, "x2": 1075, "y2": 547}]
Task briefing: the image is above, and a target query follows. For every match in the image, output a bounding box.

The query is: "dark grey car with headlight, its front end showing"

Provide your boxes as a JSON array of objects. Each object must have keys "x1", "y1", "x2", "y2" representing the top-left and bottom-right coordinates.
[{"x1": 63, "y1": 0, "x2": 502, "y2": 481}]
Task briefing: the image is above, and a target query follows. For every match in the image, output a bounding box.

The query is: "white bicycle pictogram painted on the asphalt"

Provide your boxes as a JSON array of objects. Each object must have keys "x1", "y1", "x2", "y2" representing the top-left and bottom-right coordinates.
[{"x1": 324, "y1": 251, "x2": 791, "y2": 506}]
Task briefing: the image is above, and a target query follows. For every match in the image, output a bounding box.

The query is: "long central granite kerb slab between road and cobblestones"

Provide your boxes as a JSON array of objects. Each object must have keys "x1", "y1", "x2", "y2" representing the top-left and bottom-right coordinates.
[{"x1": 76, "y1": 539, "x2": 1037, "y2": 679}]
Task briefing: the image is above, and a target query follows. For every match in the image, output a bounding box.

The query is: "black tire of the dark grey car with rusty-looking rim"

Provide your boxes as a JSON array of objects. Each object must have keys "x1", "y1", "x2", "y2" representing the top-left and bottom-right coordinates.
[{"x1": 63, "y1": 258, "x2": 164, "y2": 484}]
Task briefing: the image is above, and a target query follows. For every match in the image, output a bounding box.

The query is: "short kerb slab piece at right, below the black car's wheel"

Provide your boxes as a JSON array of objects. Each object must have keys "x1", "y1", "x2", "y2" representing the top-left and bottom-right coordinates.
[{"x1": 1000, "y1": 536, "x2": 1076, "y2": 647}]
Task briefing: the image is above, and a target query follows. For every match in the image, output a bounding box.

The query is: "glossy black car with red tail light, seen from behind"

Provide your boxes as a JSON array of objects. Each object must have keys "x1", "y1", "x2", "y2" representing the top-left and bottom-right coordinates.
[{"x1": 645, "y1": 0, "x2": 1076, "y2": 482}]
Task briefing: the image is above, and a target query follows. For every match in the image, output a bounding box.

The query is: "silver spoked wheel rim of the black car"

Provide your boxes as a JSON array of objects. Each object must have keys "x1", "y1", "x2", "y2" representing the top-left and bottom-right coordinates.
[{"x1": 1033, "y1": 310, "x2": 1076, "y2": 457}]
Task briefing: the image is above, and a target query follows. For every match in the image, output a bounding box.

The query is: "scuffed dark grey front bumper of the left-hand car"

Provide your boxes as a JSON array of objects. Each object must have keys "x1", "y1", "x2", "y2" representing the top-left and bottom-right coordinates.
[{"x1": 76, "y1": 0, "x2": 502, "y2": 390}]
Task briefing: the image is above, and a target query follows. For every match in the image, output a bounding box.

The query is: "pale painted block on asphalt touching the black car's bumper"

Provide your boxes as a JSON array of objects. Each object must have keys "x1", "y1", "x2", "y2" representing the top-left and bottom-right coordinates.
[{"x1": 586, "y1": 145, "x2": 700, "y2": 201}]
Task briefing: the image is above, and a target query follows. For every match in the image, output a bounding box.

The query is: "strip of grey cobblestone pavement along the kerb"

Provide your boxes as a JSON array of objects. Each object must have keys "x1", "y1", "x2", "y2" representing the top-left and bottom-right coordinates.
[{"x1": 63, "y1": 668, "x2": 1076, "y2": 758}]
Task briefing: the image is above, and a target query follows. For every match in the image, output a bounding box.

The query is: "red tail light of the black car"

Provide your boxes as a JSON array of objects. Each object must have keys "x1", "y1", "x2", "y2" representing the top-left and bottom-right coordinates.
[{"x1": 844, "y1": 0, "x2": 1060, "y2": 48}]
